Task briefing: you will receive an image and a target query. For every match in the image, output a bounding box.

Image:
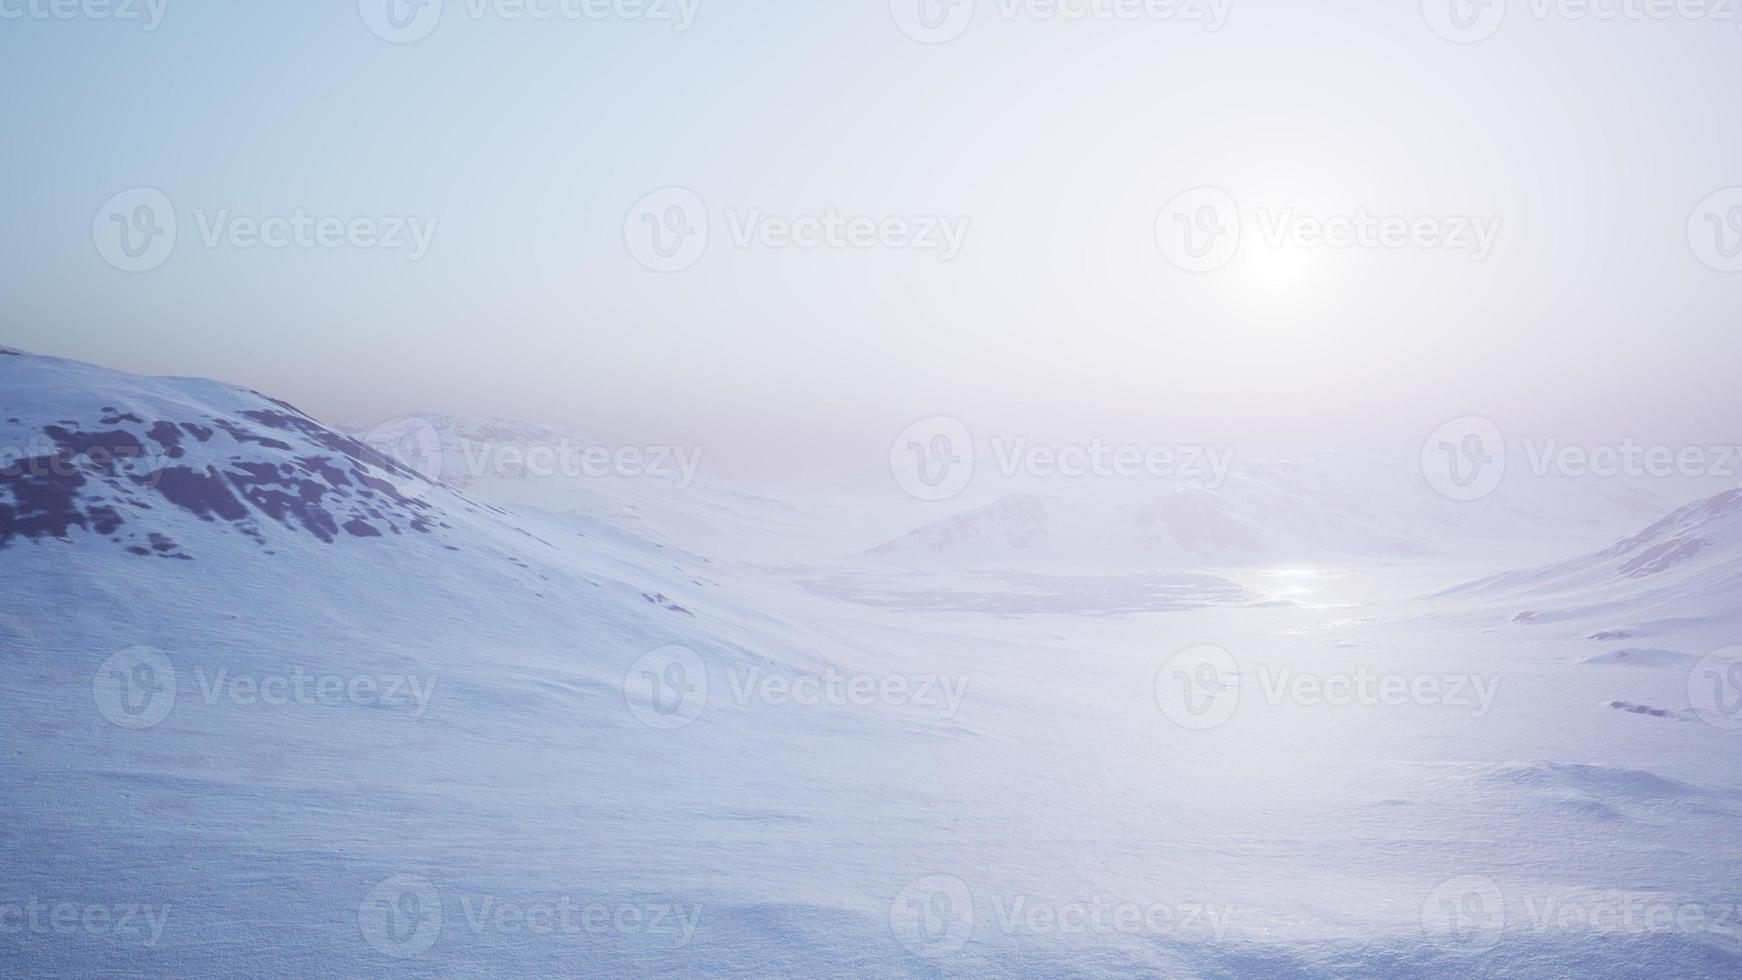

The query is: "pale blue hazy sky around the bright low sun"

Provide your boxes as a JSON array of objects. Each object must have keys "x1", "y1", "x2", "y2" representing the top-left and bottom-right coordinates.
[{"x1": 0, "y1": 0, "x2": 1742, "y2": 472}]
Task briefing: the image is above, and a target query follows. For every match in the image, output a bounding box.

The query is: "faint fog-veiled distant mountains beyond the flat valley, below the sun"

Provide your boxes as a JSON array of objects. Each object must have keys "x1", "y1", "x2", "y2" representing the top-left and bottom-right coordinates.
[{"x1": 869, "y1": 453, "x2": 1679, "y2": 567}]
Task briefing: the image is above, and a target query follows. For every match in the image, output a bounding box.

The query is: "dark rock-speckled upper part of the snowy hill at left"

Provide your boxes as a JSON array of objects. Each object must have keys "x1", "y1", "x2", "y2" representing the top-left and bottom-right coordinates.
[{"x1": 0, "y1": 352, "x2": 479, "y2": 560}]
